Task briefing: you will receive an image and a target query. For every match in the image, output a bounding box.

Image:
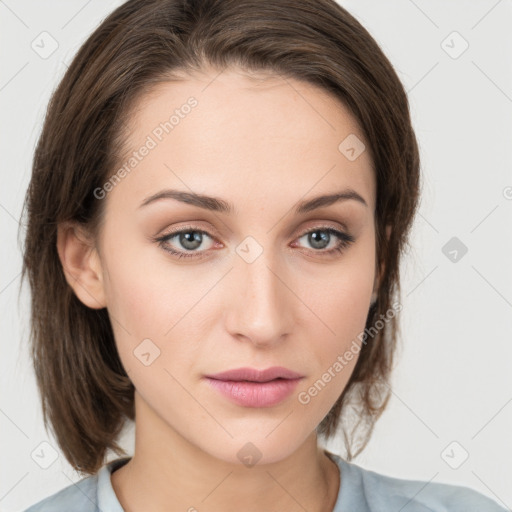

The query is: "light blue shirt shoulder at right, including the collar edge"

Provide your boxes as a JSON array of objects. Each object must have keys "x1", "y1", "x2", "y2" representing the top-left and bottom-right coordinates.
[{"x1": 332, "y1": 454, "x2": 506, "y2": 512}]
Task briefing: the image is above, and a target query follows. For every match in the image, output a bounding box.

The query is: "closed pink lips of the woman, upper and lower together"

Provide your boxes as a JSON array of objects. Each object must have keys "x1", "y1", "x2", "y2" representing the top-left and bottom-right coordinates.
[{"x1": 205, "y1": 366, "x2": 303, "y2": 407}]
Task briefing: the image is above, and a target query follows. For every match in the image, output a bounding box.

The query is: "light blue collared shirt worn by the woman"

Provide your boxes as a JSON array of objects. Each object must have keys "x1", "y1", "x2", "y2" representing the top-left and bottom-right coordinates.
[{"x1": 25, "y1": 452, "x2": 506, "y2": 512}]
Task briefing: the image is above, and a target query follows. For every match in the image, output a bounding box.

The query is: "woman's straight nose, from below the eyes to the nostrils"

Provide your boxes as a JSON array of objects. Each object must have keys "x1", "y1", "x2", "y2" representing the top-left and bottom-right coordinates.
[{"x1": 225, "y1": 251, "x2": 300, "y2": 347}]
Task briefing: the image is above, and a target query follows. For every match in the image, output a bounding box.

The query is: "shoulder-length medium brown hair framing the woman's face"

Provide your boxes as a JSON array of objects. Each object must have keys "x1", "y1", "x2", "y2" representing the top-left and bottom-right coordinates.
[{"x1": 22, "y1": 0, "x2": 420, "y2": 474}]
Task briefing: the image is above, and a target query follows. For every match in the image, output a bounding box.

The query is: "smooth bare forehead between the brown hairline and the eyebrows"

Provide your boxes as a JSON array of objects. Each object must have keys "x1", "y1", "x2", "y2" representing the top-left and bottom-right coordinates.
[{"x1": 112, "y1": 69, "x2": 375, "y2": 211}]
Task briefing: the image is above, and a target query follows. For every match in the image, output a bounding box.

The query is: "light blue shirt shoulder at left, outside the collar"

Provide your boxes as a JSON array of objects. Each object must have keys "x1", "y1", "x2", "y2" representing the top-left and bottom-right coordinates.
[{"x1": 25, "y1": 475, "x2": 98, "y2": 512}]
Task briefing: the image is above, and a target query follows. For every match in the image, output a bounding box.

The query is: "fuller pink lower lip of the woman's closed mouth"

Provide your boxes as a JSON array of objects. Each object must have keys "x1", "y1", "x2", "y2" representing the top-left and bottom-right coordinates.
[{"x1": 206, "y1": 377, "x2": 301, "y2": 407}]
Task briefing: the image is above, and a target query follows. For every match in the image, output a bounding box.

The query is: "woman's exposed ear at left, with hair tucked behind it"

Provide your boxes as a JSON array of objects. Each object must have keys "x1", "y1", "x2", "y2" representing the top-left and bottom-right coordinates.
[{"x1": 57, "y1": 222, "x2": 106, "y2": 309}]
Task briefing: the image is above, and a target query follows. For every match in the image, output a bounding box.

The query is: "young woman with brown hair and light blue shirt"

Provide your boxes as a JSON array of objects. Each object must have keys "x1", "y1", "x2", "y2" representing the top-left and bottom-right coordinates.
[{"x1": 24, "y1": 0, "x2": 502, "y2": 512}]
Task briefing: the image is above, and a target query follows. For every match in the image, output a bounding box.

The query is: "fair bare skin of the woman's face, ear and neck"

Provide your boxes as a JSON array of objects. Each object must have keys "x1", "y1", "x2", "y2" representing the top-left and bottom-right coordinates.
[{"x1": 58, "y1": 69, "x2": 388, "y2": 512}]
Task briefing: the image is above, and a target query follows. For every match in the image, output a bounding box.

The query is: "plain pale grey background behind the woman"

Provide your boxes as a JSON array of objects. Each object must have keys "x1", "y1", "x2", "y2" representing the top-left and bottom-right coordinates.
[{"x1": 0, "y1": 0, "x2": 512, "y2": 511}]
